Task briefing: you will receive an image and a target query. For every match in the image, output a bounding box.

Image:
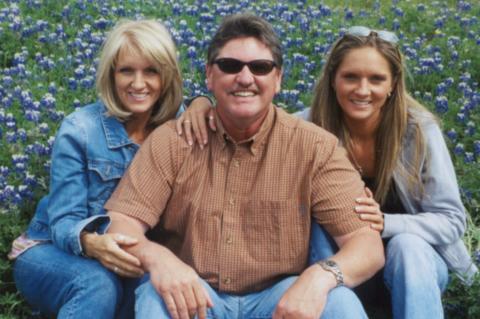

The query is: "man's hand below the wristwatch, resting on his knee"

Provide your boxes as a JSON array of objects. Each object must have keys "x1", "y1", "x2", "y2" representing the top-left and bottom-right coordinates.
[{"x1": 273, "y1": 264, "x2": 336, "y2": 319}]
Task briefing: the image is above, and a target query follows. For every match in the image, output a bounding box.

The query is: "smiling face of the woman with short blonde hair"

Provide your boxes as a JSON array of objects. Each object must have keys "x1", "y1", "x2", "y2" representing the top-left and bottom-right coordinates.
[{"x1": 114, "y1": 49, "x2": 162, "y2": 121}]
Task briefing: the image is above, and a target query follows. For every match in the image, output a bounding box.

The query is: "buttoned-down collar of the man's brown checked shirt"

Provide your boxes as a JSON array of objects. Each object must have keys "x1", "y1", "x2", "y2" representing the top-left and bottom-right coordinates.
[{"x1": 215, "y1": 104, "x2": 276, "y2": 155}]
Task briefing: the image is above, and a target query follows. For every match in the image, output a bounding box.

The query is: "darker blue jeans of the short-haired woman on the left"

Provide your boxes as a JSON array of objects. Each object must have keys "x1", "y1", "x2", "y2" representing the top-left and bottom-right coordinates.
[{"x1": 14, "y1": 243, "x2": 138, "y2": 319}]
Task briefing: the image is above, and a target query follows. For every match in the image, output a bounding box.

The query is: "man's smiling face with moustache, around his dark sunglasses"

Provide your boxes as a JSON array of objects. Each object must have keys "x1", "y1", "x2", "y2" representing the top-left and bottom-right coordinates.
[{"x1": 206, "y1": 37, "x2": 282, "y2": 130}]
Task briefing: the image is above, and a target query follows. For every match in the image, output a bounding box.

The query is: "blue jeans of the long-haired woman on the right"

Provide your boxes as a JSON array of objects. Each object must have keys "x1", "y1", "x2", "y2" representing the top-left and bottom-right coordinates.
[{"x1": 310, "y1": 224, "x2": 448, "y2": 318}]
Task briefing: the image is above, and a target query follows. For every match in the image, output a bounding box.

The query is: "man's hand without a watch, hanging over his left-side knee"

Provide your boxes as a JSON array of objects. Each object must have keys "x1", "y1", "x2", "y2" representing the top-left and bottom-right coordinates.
[{"x1": 149, "y1": 247, "x2": 213, "y2": 319}]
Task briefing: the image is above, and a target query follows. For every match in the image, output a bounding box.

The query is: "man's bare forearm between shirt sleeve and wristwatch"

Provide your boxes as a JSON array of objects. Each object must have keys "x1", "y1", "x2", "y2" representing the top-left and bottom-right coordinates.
[{"x1": 331, "y1": 227, "x2": 385, "y2": 287}]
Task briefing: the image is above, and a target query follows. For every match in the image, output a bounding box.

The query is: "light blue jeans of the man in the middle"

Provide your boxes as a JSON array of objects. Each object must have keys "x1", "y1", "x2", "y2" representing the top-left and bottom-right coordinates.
[{"x1": 135, "y1": 276, "x2": 367, "y2": 319}]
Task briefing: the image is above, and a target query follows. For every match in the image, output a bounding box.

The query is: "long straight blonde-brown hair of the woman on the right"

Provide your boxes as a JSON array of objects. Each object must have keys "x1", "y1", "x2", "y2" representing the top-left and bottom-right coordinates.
[{"x1": 311, "y1": 34, "x2": 428, "y2": 204}]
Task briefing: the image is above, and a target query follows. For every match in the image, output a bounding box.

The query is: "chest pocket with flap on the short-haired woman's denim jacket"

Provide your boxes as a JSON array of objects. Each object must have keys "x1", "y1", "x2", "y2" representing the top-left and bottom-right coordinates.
[{"x1": 88, "y1": 159, "x2": 126, "y2": 211}]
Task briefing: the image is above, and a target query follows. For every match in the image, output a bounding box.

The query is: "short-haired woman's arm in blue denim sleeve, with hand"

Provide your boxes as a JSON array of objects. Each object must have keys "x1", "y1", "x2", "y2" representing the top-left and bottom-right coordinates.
[{"x1": 47, "y1": 117, "x2": 143, "y2": 277}]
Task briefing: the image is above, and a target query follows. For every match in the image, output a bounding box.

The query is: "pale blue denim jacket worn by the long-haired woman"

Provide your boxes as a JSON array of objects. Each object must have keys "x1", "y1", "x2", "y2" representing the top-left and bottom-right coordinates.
[{"x1": 296, "y1": 108, "x2": 478, "y2": 282}]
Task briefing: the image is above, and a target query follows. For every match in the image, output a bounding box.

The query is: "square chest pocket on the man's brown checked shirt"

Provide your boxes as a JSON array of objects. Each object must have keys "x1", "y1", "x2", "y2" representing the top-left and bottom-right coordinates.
[{"x1": 242, "y1": 200, "x2": 310, "y2": 263}]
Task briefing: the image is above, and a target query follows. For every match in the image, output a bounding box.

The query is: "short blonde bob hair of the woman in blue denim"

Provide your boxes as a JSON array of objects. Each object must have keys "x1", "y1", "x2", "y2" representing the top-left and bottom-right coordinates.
[{"x1": 96, "y1": 20, "x2": 183, "y2": 126}]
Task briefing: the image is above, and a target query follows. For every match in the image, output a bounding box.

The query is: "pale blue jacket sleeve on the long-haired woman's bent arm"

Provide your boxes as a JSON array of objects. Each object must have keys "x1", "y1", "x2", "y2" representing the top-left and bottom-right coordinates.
[{"x1": 383, "y1": 121, "x2": 466, "y2": 245}]
